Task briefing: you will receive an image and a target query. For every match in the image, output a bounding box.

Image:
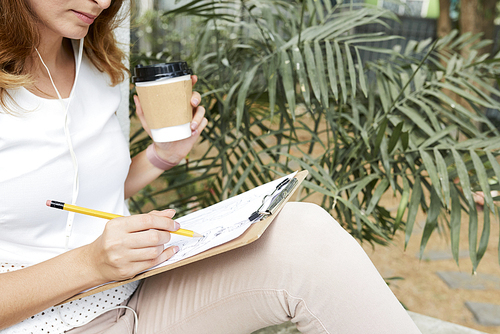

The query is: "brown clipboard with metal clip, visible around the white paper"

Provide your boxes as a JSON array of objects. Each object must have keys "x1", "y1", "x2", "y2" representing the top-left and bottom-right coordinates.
[{"x1": 60, "y1": 170, "x2": 308, "y2": 306}]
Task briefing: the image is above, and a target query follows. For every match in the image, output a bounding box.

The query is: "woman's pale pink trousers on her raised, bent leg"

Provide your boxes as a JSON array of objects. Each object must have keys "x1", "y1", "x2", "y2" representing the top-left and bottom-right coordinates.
[{"x1": 68, "y1": 203, "x2": 420, "y2": 334}]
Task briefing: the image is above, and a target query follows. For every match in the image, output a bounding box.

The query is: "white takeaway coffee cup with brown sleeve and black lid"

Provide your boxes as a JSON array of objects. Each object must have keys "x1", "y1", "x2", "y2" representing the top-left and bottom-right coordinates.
[{"x1": 133, "y1": 62, "x2": 193, "y2": 142}]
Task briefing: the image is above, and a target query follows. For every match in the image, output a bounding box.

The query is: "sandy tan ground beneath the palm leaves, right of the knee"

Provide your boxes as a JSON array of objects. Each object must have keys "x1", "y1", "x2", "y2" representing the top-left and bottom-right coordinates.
[{"x1": 363, "y1": 190, "x2": 500, "y2": 334}]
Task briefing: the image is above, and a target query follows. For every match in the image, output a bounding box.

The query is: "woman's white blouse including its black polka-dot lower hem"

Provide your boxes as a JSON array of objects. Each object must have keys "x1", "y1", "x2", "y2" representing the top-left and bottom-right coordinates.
[{"x1": 0, "y1": 42, "x2": 138, "y2": 334}]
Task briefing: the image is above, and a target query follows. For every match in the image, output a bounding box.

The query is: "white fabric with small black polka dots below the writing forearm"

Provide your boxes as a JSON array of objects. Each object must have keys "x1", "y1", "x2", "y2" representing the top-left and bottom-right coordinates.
[{"x1": 0, "y1": 263, "x2": 139, "y2": 334}]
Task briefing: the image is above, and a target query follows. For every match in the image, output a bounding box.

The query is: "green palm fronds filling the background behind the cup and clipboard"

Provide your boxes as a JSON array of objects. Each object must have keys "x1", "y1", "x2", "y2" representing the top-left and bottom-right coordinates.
[{"x1": 131, "y1": 0, "x2": 500, "y2": 271}]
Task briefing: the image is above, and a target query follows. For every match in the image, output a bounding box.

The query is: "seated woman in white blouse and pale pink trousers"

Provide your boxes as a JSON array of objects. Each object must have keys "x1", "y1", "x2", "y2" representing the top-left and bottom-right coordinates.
[{"x1": 0, "y1": 0, "x2": 419, "y2": 334}]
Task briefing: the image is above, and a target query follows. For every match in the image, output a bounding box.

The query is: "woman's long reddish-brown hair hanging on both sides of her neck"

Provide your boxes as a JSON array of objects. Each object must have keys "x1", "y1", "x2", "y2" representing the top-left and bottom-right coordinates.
[{"x1": 0, "y1": 0, "x2": 128, "y2": 111}]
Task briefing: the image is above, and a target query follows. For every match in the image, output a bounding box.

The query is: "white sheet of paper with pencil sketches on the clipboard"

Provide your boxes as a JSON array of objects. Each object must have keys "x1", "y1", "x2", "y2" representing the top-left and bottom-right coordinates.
[{"x1": 149, "y1": 173, "x2": 296, "y2": 270}]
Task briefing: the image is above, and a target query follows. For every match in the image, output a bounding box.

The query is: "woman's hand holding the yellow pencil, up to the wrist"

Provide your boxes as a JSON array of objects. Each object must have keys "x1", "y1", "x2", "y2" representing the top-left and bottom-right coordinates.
[{"x1": 88, "y1": 209, "x2": 180, "y2": 283}]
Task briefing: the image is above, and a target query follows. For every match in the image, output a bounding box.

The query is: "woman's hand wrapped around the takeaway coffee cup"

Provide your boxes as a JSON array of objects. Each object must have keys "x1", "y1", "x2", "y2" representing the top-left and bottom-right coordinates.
[{"x1": 134, "y1": 75, "x2": 208, "y2": 165}]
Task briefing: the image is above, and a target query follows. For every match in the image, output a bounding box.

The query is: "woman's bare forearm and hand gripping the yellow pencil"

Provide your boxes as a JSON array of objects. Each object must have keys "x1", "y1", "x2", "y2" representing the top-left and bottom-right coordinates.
[{"x1": 0, "y1": 210, "x2": 179, "y2": 331}]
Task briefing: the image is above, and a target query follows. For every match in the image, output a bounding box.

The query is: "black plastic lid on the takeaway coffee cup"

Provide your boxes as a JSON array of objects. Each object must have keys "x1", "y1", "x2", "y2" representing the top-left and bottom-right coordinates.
[{"x1": 132, "y1": 61, "x2": 193, "y2": 83}]
